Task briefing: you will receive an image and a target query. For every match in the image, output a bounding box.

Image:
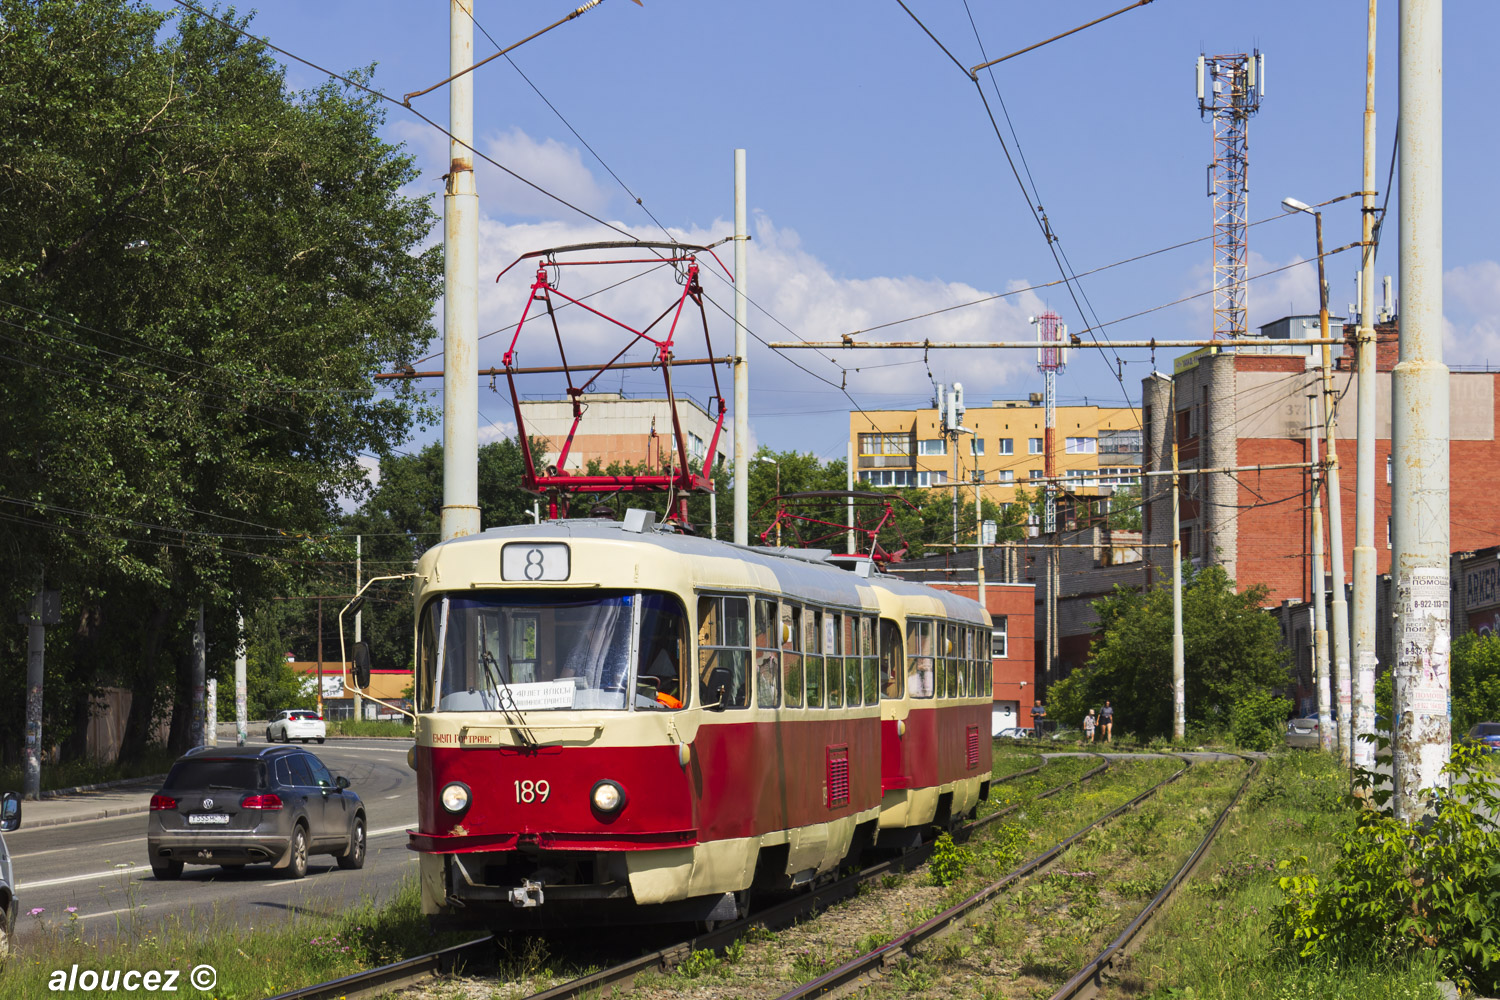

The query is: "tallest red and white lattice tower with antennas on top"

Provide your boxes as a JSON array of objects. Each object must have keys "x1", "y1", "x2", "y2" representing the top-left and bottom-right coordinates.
[{"x1": 1199, "y1": 49, "x2": 1266, "y2": 340}]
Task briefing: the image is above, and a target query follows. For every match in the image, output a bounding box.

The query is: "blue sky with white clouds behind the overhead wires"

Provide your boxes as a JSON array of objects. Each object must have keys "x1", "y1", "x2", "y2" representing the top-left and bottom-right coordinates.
[{"x1": 158, "y1": 0, "x2": 1500, "y2": 457}]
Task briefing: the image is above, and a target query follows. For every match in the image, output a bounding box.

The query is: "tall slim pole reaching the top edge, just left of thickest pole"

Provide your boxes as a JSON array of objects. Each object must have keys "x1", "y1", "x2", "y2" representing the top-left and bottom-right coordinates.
[{"x1": 1353, "y1": 0, "x2": 1379, "y2": 769}]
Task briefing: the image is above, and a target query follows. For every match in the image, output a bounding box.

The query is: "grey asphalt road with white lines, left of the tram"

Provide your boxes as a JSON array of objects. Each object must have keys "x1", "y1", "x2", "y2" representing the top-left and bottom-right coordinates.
[{"x1": 6, "y1": 739, "x2": 417, "y2": 943}]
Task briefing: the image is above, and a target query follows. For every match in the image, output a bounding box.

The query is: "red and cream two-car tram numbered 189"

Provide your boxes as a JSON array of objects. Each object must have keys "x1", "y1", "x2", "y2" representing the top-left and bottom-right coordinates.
[{"x1": 410, "y1": 511, "x2": 990, "y2": 928}]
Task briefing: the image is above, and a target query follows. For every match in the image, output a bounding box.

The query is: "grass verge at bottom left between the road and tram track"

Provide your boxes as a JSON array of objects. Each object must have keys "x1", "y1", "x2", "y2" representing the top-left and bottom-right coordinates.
[{"x1": 0, "y1": 877, "x2": 476, "y2": 1000}]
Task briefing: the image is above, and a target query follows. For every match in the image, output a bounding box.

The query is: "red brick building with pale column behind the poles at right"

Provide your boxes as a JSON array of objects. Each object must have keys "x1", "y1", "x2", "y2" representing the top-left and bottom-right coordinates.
[{"x1": 1142, "y1": 316, "x2": 1500, "y2": 603}]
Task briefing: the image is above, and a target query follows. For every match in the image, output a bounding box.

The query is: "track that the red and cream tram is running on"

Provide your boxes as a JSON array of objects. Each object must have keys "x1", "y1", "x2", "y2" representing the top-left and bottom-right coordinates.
[{"x1": 269, "y1": 754, "x2": 1110, "y2": 1000}]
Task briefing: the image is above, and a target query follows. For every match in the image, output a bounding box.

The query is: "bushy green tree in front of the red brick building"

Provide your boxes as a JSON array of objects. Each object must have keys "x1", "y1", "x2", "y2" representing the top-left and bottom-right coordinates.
[{"x1": 1047, "y1": 567, "x2": 1289, "y2": 738}]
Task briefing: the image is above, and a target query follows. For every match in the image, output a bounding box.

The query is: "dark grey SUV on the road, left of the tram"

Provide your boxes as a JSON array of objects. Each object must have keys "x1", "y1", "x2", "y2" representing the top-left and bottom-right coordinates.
[{"x1": 146, "y1": 747, "x2": 368, "y2": 882}]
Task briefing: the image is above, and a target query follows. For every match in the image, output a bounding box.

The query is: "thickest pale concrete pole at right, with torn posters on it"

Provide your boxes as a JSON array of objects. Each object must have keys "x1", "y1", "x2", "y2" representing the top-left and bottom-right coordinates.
[{"x1": 1391, "y1": 0, "x2": 1451, "y2": 820}]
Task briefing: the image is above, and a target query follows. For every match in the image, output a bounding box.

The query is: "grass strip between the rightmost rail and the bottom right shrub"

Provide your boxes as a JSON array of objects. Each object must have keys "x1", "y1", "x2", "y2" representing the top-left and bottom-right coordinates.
[{"x1": 1103, "y1": 751, "x2": 1440, "y2": 1000}]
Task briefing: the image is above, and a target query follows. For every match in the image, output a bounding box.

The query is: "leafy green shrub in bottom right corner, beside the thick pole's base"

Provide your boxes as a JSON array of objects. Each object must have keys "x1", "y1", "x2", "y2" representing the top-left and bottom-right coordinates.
[{"x1": 1272, "y1": 745, "x2": 1500, "y2": 993}]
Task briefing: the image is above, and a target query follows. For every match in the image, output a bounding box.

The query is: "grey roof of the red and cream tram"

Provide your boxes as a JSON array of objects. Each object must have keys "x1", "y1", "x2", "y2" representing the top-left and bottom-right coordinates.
[{"x1": 429, "y1": 517, "x2": 984, "y2": 624}]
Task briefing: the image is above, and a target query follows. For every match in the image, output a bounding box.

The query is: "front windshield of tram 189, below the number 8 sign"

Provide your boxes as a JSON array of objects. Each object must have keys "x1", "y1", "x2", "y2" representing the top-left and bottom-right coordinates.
[{"x1": 419, "y1": 591, "x2": 686, "y2": 712}]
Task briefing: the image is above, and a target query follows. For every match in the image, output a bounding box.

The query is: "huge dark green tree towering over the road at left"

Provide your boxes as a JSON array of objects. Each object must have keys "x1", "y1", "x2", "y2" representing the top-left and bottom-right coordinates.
[{"x1": 0, "y1": 0, "x2": 441, "y2": 753}]
